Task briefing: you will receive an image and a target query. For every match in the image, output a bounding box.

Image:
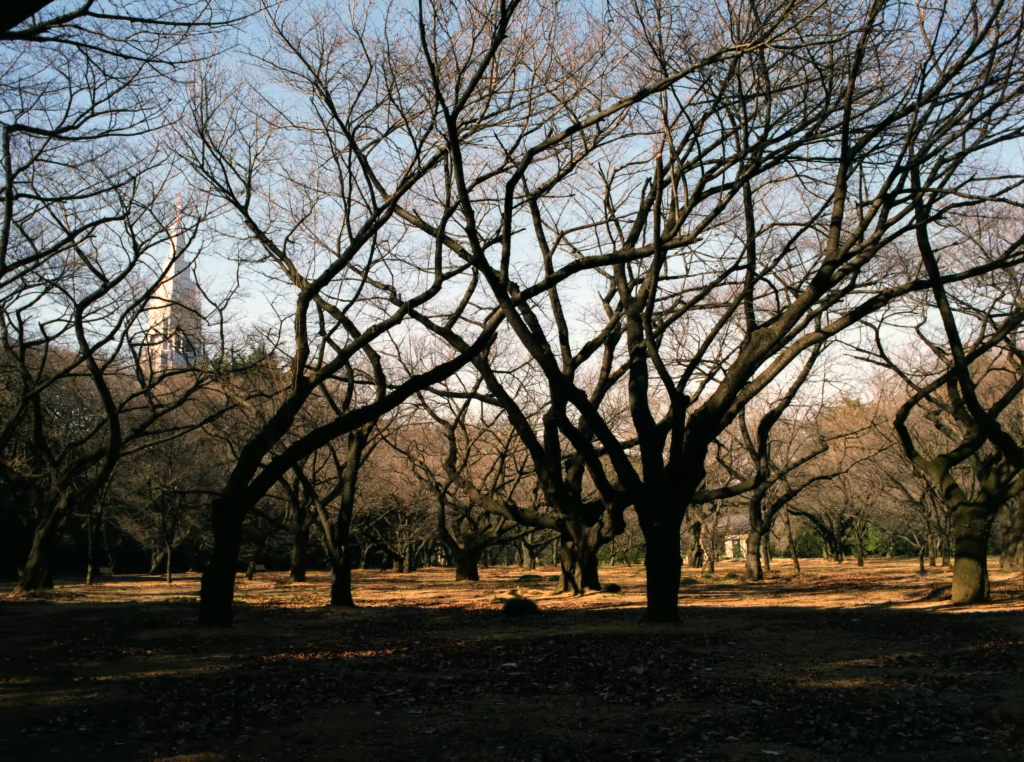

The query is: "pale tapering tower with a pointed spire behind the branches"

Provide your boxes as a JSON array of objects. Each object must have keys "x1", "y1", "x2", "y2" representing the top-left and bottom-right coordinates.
[{"x1": 142, "y1": 205, "x2": 203, "y2": 374}]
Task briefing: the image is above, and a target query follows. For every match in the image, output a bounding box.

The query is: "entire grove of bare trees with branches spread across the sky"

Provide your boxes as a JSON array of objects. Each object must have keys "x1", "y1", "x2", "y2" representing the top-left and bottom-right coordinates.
[{"x1": 0, "y1": 0, "x2": 1024, "y2": 626}]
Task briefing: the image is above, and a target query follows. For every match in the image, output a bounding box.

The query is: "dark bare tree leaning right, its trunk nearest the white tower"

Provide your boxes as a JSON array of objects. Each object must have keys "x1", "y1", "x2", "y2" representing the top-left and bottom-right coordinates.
[{"x1": 180, "y1": 1, "x2": 520, "y2": 626}]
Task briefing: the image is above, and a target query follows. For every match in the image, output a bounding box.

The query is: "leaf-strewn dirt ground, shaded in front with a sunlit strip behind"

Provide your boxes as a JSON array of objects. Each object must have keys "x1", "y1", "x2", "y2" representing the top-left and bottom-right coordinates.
[{"x1": 0, "y1": 559, "x2": 1024, "y2": 762}]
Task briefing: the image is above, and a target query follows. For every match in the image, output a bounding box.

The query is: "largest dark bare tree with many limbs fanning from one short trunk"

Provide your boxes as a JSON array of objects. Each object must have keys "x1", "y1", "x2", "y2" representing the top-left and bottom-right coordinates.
[{"x1": 405, "y1": 2, "x2": 1022, "y2": 621}]
